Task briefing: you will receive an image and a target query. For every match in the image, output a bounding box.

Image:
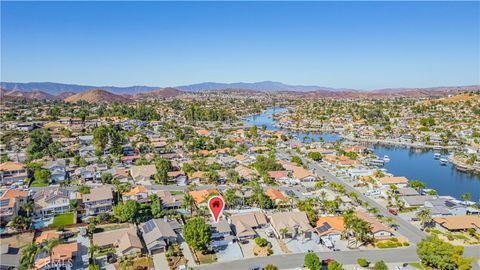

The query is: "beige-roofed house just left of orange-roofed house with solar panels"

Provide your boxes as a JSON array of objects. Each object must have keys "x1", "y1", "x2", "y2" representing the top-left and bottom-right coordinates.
[{"x1": 268, "y1": 211, "x2": 313, "y2": 238}]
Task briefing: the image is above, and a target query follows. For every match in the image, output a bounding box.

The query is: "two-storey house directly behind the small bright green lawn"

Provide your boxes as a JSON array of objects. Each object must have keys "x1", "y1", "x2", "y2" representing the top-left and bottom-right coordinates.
[{"x1": 32, "y1": 188, "x2": 70, "y2": 219}]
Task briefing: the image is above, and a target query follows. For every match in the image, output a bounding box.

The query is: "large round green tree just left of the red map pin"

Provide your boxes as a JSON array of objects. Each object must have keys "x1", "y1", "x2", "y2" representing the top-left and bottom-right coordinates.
[{"x1": 183, "y1": 217, "x2": 210, "y2": 251}]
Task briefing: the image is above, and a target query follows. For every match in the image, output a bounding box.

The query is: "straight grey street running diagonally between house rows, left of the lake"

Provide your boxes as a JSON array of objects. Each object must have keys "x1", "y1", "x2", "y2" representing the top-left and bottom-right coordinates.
[{"x1": 282, "y1": 150, "x2": 426, "y2": 244}]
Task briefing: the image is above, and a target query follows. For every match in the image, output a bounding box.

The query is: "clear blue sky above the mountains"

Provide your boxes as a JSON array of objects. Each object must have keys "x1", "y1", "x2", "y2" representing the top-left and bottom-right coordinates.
[{"x1": 1, "y1": 1, "x2": 480, "y2": 89}]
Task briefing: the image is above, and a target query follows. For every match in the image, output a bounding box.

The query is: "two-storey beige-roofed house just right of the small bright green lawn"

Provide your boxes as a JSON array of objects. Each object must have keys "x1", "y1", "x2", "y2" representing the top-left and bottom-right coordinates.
[{"x1": 82, "y1": 186, "x2": 114, "y2": 215}]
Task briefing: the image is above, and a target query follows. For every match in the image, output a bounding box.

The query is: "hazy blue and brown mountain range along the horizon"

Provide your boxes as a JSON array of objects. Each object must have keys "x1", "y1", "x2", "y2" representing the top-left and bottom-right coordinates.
[{"x1": 0, "y1": 81, "x2": 480, "y2": 103}]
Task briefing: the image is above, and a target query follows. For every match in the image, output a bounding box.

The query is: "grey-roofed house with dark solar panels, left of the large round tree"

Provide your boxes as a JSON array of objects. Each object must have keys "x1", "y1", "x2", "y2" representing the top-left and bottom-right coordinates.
[{"x1": 140, "y1": 219, "x2": 178, "y2": 254}]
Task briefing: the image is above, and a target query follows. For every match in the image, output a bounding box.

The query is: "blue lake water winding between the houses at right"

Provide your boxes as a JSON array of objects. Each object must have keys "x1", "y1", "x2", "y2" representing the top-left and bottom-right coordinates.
[{"x1": 245, "y1": 108, "x2": 480, "y2": 201}]
